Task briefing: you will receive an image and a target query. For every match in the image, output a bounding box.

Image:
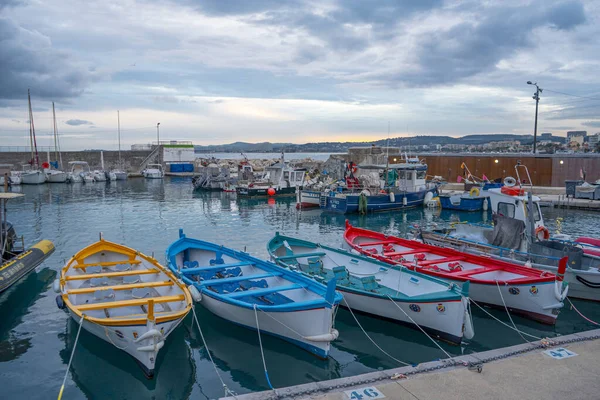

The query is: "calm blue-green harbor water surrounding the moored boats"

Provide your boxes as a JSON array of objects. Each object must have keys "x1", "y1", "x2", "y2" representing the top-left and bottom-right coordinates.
[{"x1": 0, "y1": 178, "x2": 600, "y2": 399}]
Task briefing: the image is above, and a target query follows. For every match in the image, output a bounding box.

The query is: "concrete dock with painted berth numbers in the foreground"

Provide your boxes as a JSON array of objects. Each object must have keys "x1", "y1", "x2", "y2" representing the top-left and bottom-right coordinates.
[{"x1": 227, "y1": 329, "x2": 600, "y2": 400}]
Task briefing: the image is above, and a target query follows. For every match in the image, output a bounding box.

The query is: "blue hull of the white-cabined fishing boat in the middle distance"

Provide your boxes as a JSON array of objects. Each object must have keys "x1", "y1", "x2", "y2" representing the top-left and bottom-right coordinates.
[{"x1": 320, "y1": 189, "x2": 437, "y2": 214}]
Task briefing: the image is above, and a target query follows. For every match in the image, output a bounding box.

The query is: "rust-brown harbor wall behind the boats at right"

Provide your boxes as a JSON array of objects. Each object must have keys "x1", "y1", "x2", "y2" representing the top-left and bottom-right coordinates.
[{"x1": 406, "y1": 153, "x2": 600, "y2": 187}]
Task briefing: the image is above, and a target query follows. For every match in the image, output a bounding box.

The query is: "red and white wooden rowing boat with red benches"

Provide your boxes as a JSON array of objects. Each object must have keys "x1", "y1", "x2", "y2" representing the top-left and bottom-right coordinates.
[{"x1": 344, "y1": 221, "x2": 569, "y2": 325}]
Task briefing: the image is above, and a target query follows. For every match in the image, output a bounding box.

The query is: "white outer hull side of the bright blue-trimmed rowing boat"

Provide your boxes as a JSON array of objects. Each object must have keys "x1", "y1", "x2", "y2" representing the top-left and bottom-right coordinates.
[{"x1": 200, "y1": 290, "x2": 335, "y2": 358}]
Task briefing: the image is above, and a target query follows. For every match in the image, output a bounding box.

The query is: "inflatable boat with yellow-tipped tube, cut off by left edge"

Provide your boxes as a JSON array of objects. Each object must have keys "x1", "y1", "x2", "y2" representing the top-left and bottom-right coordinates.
[{"x1": 0, "y1": 193, "x2": 54, "y2": 293}]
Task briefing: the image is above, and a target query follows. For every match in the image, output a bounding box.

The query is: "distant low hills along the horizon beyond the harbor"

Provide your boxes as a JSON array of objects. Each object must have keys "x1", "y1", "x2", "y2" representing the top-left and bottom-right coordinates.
[{"x1": 194, "y1": 134, "x2": 565, "y2": 153}]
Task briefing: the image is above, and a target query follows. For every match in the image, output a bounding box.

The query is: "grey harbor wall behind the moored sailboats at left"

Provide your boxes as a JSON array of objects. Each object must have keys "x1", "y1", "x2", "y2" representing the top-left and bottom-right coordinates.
[{"x1": 0, "y1": 150, "x2": 150, "y2": 172}]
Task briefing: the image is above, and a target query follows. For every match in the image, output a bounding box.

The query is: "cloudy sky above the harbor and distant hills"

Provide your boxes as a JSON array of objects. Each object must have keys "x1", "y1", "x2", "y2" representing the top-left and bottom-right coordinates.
[{"x1": 0, "y1": 0, "x2": 600, "y2": 149}]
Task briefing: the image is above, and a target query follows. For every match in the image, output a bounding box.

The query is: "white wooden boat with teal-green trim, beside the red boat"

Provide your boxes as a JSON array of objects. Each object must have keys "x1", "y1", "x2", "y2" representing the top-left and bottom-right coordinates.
[{"x1": 267, "y1": 233, "x2": 474, "y2": 344}]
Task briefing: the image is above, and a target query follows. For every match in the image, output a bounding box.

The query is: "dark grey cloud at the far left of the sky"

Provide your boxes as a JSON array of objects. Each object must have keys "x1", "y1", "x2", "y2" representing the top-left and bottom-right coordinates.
[{"x1": 0, "y1": 18, "x2": 93, "y2": 99}]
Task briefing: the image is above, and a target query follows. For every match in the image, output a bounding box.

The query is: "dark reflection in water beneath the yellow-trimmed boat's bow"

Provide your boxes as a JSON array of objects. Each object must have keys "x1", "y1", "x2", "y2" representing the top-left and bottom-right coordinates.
[{"x1": 59, "y1": 318, "x2": 196, "y2": 400}]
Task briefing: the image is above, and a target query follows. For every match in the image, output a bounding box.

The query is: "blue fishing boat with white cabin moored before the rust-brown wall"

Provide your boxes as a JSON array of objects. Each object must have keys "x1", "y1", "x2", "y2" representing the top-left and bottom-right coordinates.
[{"x1": 320, "y1": 157, "x2": 437, "y2": 214}]
